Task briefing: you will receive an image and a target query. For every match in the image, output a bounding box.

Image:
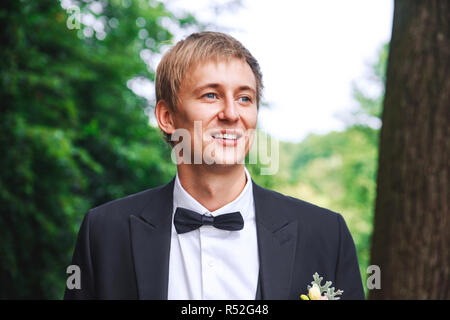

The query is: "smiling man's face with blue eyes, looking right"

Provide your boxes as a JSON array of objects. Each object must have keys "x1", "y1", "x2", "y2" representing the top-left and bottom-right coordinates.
[{"x1": 173, "y1": 58, "x2": 258, "y2": 165}]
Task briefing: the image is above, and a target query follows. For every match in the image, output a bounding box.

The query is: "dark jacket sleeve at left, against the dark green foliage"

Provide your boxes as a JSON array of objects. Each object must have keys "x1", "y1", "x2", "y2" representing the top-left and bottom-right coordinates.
[{"x1": 64, "y1": 211, "x2": 95, "y2": 300}]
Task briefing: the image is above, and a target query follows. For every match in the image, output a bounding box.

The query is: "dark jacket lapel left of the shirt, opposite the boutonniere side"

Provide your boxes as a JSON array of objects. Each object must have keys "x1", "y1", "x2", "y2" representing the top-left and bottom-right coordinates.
[{"x1": 130, "y1": 179, "x2": 175, "y2": 300}]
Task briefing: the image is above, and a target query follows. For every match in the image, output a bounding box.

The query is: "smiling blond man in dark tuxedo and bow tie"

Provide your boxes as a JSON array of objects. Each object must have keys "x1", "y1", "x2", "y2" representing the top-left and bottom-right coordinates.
[{"x1": 65, "y1": 32, "x2": 364, "y2": 299}]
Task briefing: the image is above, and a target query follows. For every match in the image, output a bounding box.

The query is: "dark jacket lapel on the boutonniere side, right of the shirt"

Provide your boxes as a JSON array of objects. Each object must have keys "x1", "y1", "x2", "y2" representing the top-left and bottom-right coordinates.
[{"x1": 253, "y1": 182, "x2": 298, "y2": 300}]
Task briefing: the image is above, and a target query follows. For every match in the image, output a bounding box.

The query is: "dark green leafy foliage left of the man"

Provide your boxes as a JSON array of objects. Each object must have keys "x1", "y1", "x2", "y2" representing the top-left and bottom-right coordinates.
[{"x1": 0, "y1": 0, "x2": 192, "y2": 298}]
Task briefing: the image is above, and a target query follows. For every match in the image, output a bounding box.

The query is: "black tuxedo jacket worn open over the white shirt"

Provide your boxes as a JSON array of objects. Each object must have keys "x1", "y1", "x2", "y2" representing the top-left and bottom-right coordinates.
[{"x1": 64, "y1": 179, "x2": 364, "y2": 299}]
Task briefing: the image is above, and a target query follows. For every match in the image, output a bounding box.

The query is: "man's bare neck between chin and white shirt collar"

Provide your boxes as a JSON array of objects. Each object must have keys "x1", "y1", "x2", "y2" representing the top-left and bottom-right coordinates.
[{"x1": 178, "y1": 164, "x2": 247, "y2": 212}]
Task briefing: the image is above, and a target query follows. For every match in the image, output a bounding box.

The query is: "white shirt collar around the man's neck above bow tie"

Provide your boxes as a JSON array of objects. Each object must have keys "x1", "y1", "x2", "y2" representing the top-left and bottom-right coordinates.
[{"x1": 173, "y1": 167, "x2": 253, "y2": 220}]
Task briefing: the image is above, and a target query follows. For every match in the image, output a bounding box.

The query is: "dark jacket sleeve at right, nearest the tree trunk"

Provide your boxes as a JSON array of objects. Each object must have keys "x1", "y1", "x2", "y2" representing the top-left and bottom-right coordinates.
[{"x1": 335, "y1": 214, "x2": 364, "y2": 300}]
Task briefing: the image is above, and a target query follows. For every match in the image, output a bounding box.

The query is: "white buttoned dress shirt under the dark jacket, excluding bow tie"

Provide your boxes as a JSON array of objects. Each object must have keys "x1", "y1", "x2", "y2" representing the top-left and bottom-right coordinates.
[{"x1": 168, "y1": 168, "x2": 259, "y2": 300}]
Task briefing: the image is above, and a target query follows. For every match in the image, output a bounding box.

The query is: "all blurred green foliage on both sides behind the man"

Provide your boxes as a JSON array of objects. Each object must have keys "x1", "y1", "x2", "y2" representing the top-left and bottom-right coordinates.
[{"x1": 0, "y1": 0, "x2": 387, "y2": 299}]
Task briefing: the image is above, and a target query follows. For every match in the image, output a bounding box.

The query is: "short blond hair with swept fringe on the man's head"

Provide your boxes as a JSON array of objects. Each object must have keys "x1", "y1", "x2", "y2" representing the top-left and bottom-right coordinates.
[{"x1": 155, "y1": 31, "x2": 263, "y2": 139}]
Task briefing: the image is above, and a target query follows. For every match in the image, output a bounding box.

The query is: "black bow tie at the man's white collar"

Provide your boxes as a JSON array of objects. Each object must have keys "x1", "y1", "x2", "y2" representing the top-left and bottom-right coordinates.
[{"x1": 173, "y1": 207, "x2": 244, "y2": 233}]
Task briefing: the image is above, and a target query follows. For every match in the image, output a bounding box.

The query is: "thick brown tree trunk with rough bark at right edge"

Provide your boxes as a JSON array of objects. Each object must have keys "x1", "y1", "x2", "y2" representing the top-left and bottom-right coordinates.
[{"x1": 369, "y1": 0, "x2": 450, "y2": 299}]
